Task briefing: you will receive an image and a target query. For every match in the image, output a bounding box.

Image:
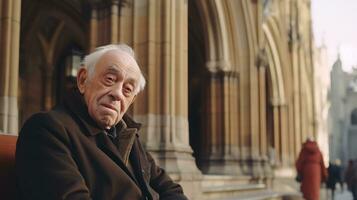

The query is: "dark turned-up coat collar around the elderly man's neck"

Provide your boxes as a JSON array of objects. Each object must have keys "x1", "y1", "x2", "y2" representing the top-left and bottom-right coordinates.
[{"x1": 64, "y1": 88, "x2": 141, "y2": 136}]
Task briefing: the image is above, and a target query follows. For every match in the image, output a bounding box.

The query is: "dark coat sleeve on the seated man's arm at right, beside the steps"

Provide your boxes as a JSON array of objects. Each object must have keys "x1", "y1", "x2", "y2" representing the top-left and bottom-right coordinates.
[{"x1": 146, "y1": 153, "x2": 188, "y2": 200}]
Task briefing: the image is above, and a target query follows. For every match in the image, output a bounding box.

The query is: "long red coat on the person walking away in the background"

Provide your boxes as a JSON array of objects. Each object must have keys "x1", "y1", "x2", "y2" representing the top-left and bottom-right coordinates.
[{"x1": 296, "y1": 141, "x2": 327, "y2": 200}]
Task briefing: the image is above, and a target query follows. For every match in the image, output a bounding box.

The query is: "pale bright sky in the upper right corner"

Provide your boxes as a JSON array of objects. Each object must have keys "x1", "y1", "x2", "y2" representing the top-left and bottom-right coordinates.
[{"x1": 311, "y1": 0, "x2": 357, "y2": 71}]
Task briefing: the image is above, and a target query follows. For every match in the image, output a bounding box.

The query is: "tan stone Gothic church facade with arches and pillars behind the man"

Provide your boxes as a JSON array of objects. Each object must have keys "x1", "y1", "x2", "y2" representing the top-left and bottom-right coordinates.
[{"x1": 0, "y1": 0, "x2": 316, "y2": 199}]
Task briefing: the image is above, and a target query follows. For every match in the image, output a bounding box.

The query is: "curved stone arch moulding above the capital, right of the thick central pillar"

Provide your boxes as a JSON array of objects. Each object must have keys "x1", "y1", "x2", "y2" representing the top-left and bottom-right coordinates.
[{"x1": 192, "y1": 0, "x2": 250, "y2": 72}]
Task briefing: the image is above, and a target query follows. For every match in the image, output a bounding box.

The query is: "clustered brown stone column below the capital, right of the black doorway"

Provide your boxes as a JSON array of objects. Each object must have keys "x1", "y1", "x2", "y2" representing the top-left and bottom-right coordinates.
[{"x1": 201, "y1": 71, "x2": 241, "y2": 175}]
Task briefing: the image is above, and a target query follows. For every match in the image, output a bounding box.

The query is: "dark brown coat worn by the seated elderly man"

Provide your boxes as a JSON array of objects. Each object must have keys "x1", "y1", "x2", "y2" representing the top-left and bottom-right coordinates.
[{"x1": 16, "y1": 91, "x2": 187, "y2": 200}]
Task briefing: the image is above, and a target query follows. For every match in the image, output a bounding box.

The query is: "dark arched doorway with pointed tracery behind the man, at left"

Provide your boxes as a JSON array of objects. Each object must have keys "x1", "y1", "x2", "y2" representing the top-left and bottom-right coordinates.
[{"x1": 19, "y1": 0, "x2": 89, "y2": 126}]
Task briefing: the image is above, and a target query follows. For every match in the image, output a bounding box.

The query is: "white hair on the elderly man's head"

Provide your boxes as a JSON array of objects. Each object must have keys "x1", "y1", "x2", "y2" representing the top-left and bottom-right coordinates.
[{"x1": 82, "y1": 44, "x2": 146, "y2": 94}]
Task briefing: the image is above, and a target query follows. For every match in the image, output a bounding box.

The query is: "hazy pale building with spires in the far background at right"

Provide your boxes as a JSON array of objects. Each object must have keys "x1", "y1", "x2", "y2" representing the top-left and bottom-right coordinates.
[{"x1": 329, "y1": 57, "x2": 357, "y2": 166}]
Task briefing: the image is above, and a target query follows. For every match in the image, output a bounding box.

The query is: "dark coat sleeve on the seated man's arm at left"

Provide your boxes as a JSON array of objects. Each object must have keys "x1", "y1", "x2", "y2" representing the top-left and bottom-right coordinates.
[{"x1": 16, "y1": 113, "x2": 91, "y2": 200}]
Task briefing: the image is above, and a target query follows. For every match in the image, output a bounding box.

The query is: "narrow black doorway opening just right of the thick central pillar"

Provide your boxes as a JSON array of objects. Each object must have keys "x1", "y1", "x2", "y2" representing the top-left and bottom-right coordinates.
[{"x1": 188, "y1": 1, "x2": 208, "y2": 167}]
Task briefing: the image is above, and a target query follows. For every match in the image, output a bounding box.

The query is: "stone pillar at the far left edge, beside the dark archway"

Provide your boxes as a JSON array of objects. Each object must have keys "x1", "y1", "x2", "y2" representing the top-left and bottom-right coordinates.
[{"x1": 0, "y1": 0, "x2": 21, "y2": 135}]
